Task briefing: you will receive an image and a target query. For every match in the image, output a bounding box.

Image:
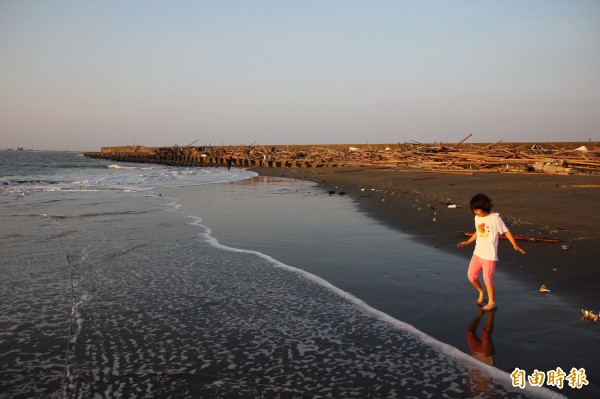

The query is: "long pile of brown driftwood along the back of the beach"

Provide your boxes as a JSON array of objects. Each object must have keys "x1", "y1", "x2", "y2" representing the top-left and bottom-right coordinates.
[{"x1": 150, "y1": 141, "x2": 600, "y2": 174}]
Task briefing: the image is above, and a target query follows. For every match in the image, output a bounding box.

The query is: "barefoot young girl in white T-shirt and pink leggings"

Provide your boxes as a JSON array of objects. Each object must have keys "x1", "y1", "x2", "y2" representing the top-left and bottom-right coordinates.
[{"x1": 456, "y1": 194, "x2": 525, "y2": 310}]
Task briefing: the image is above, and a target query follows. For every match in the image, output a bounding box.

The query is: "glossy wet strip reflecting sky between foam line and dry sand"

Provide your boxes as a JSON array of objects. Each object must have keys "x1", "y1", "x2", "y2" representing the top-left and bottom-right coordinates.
[{"x1": 167, "y1": 177, "x2": 598, "y2": 397}]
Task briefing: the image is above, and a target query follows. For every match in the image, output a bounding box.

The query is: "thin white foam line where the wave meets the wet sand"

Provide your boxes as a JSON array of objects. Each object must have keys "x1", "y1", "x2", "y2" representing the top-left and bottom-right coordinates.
[{"x1": 176, "y1": 212, "x2": 566, "y2": 399}]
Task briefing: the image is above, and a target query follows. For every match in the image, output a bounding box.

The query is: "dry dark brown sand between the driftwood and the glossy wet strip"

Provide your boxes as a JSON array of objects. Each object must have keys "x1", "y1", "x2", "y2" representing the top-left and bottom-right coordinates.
[{"x1": 253, "y1": 168, "x2": 600, "y2": 311}]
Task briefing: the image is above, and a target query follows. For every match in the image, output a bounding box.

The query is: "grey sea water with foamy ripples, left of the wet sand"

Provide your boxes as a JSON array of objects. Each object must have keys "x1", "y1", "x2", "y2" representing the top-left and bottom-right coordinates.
[{"x1": 0, "y1": 151, "x2": 559, "y2": 398}]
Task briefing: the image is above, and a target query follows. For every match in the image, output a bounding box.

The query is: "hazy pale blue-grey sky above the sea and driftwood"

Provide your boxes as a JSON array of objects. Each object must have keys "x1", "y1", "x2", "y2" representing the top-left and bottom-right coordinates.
[{"x1": 0, "y1": 0, "x2": 600, "y2": 151}]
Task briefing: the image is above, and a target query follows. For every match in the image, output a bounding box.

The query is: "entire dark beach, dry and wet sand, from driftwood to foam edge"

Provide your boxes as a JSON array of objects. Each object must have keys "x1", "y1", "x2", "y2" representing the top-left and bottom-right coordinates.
[{"x1": 165, "y1": 168, "x2": 600, "y2": 398}]
